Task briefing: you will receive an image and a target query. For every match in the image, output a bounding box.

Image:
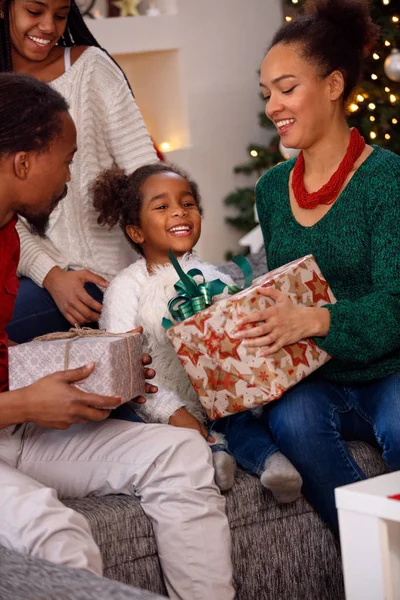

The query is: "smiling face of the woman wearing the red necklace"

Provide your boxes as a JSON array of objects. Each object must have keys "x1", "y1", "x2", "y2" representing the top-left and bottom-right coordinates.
[{"x1": 260, "y1": 44, "x2": 343, "y2": 149}]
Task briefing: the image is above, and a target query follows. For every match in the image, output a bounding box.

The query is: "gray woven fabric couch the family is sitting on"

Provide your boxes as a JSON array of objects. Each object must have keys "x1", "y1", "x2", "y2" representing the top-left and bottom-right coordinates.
[{"x1": 0, "y1": 252, "x2": 385, "y2": 600}]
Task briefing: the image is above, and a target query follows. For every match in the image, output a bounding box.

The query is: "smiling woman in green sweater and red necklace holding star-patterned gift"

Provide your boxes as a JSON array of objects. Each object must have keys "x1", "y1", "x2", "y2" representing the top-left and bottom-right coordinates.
[{"x1": 233, "y1": 0, "x2": 400, "y2": 532}]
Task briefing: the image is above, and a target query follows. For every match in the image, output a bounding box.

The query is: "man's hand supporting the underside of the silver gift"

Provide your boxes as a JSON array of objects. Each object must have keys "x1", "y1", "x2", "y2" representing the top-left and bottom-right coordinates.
[{"x1": 18, "y1": 363, "x2": 124, "y2": 429}]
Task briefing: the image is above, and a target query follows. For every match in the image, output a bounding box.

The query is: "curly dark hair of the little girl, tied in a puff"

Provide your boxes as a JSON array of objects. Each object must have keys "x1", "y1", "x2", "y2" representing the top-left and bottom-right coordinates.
[{"x1": 89, "y1": 163, "x2": 203, "y2": 256}]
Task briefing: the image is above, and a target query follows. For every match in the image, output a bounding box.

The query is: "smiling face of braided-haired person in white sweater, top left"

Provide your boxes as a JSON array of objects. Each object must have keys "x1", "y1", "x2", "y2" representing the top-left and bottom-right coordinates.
[{"x1": 10, "y1": 0, "x2": 70, "y2": 62}]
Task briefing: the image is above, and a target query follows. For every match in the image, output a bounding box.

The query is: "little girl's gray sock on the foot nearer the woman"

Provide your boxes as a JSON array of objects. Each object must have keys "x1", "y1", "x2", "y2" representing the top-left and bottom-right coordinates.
[{"x1": 260, "y1": 452, "x2": 303, "y2": 504}]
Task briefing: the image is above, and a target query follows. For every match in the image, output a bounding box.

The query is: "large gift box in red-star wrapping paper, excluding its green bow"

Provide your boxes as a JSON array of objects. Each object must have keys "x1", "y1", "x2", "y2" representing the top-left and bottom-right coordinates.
[{"x1": 164, "y1": 255, "x2": 336, "y2": 419}]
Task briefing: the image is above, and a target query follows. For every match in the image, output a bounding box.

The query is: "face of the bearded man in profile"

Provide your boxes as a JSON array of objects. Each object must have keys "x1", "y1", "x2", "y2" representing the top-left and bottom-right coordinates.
[{"x1": 13, "y1": 113, "x2": 76, "y2": 236}]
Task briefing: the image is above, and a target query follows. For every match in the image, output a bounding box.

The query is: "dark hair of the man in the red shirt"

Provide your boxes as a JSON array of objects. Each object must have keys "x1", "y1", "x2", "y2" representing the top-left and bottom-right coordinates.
[{"x1": 0, "y1": 73, "x2": 68, "y2": 157}]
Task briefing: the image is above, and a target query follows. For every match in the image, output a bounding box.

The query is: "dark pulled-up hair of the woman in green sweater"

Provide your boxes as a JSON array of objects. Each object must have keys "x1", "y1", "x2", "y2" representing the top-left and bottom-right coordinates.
[{"x1": 269, "y1": 0, "x2": 379, "y2": 102}]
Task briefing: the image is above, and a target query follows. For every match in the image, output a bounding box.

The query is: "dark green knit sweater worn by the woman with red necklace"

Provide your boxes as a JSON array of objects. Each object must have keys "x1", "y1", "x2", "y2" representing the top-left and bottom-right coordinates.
[{"x1": 256, "y1": 146, "x2": 400, "y2": 384}]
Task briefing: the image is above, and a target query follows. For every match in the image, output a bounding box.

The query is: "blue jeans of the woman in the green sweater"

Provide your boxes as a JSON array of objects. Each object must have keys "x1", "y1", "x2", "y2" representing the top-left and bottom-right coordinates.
[{"x1": 262, "y1": 373, "x2": 400, "y2": 535}]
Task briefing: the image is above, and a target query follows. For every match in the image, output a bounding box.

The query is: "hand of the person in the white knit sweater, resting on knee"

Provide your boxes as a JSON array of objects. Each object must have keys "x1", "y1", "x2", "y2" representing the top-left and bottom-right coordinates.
[{"x1": 43, "y1": 267, "x2": 108, "y2": 325}]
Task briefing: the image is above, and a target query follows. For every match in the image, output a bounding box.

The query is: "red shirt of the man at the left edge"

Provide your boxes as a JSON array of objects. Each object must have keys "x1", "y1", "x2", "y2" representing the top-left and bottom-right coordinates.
[{"x1": 0, "y1": 217, "x2": 19, "y2": 392}]
